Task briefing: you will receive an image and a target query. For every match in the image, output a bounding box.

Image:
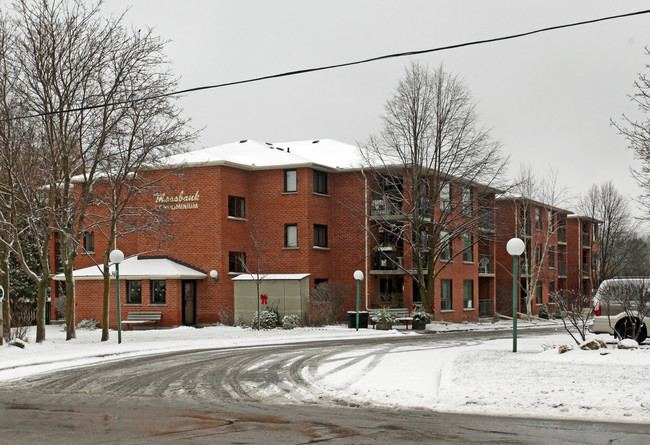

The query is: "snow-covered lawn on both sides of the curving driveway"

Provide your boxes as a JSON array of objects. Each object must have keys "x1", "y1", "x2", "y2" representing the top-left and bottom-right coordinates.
[{"x1": 0, "y1": 322, "x2": 650, "y2": 422}]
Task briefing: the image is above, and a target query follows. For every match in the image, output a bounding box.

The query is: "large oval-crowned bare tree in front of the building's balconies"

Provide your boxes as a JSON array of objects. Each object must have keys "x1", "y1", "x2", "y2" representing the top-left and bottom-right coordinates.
[{"x1": 362, "y1": 63, "x2": 506, "y2": 310}]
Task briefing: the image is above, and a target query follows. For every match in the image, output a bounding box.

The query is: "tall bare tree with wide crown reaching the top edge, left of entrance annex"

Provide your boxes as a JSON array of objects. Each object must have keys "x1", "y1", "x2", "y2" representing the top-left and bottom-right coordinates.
[{"x1": 8, "y1": 0, "x2": 192, "y2": 340}]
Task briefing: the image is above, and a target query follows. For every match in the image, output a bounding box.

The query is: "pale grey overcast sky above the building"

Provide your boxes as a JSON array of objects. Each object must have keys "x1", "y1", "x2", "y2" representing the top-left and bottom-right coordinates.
[{"x1": 103, "y1": 0, "x2": 650, "y2": 219}]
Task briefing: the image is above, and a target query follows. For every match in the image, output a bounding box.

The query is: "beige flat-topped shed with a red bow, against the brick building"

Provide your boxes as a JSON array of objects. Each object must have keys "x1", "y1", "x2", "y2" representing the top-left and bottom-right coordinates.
[{"x1": 232, "y1": 273, "x2": 310, "y2": 324}]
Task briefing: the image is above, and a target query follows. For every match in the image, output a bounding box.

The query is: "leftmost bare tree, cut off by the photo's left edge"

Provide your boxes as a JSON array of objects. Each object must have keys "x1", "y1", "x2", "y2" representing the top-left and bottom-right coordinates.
[{"x1": 0, "y1": 10, "x2": 52, "y2": 342}]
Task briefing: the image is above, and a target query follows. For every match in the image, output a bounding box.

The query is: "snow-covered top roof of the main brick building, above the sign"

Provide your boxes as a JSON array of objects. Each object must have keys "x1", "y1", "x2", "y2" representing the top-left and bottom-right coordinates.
[{"x1": 165, "y1": 139, "x2": 363, "y2": 169}]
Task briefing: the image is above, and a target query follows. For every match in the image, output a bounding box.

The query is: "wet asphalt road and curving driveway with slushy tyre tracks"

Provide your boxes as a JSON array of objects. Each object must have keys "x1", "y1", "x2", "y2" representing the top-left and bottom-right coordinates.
[{"x1": 0, "y1": 331, "x2": 650, "y2": 444}]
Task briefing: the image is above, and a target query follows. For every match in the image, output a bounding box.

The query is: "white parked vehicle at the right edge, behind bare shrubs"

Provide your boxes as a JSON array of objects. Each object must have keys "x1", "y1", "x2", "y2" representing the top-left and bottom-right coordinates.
[{"x1": 590, "y1": 277, "x2": 650, "y2": 343}]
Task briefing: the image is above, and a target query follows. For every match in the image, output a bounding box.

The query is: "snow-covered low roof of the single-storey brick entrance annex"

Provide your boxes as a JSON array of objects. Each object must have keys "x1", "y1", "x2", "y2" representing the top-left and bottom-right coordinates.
[{"x1": 54, "y1": 257, "x2": 208, "y2": 281}]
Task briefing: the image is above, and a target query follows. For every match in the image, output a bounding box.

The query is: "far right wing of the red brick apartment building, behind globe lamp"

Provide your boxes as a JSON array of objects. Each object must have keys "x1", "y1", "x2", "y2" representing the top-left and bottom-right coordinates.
[{"x1": 495, "y1": 198, "x2": 599, "y2": 315}]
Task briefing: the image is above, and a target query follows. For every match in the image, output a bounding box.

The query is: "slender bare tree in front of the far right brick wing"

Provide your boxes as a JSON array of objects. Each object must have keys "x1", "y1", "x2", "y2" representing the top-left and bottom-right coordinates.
[{"x1": 513, "y1": 166, "x2": 567, "y2": 318}]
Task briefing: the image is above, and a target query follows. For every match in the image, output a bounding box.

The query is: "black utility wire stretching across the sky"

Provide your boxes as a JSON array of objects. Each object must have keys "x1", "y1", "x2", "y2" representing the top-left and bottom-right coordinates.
[{"x1": 5, "y1": 9, "x2": 650, "y2": 122}]
